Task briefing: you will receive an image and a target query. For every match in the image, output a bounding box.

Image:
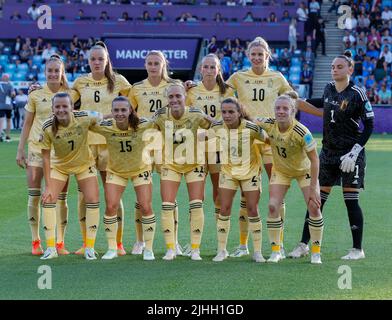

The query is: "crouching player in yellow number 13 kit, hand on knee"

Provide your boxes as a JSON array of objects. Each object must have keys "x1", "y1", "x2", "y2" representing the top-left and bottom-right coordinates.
[{"x1": 255, "y1": 92, "x2": 324, "y2": 263}]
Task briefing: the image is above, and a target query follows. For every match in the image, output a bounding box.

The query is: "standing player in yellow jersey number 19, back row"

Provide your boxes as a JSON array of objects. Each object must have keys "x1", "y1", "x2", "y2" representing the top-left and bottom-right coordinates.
[{"x1": 186, "y1": 53, "x2": 234, "y2": 226}]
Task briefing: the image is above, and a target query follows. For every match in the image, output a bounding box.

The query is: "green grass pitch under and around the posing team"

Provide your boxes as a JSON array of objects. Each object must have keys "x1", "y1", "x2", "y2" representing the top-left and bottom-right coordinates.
[{"x1": 0, "y1": 135, "x2": 392, "y2": 300}]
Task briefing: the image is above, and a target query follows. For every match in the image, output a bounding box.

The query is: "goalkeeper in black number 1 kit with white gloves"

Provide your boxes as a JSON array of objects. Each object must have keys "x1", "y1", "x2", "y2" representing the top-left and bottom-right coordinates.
[{"x1": 289, "y1": 52, "x2": 374, "y2": 260}]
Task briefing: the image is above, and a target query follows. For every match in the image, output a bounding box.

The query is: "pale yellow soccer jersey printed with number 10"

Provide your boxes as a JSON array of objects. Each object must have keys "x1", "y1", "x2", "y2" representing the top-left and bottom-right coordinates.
[{"x1": 227, "y1": 69, "x2": 293, "y2": 118}]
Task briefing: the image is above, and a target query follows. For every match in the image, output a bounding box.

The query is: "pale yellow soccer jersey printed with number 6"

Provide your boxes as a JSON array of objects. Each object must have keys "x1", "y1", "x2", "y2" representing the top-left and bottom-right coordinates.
[{"x1": 73, "y1": 73, "x2": 131, "y2": 144}]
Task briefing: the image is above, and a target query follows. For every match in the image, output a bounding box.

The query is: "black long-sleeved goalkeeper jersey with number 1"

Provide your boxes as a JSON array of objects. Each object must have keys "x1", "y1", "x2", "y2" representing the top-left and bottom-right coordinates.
[{"x1": 308, "y1": 81, "x2": 374, "y2": 153}]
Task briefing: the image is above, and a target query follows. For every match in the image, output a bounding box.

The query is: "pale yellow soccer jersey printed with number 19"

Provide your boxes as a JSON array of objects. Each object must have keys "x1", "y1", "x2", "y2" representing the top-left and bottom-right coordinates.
[{"x1": 186, "y1": 82, "x2": 234, "y2": 120}]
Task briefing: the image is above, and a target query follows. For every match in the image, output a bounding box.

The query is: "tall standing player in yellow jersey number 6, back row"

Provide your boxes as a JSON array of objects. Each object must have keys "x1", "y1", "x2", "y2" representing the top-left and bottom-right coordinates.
[{"x1": 73, "y1": 41, "x2": 131, "y2": 255}]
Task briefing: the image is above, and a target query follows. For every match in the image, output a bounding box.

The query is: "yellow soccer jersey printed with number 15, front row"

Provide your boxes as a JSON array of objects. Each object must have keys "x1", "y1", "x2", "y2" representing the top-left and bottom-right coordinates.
[{"x1": 91, "y1": 118, "x2": 156, "y2": 178}]
